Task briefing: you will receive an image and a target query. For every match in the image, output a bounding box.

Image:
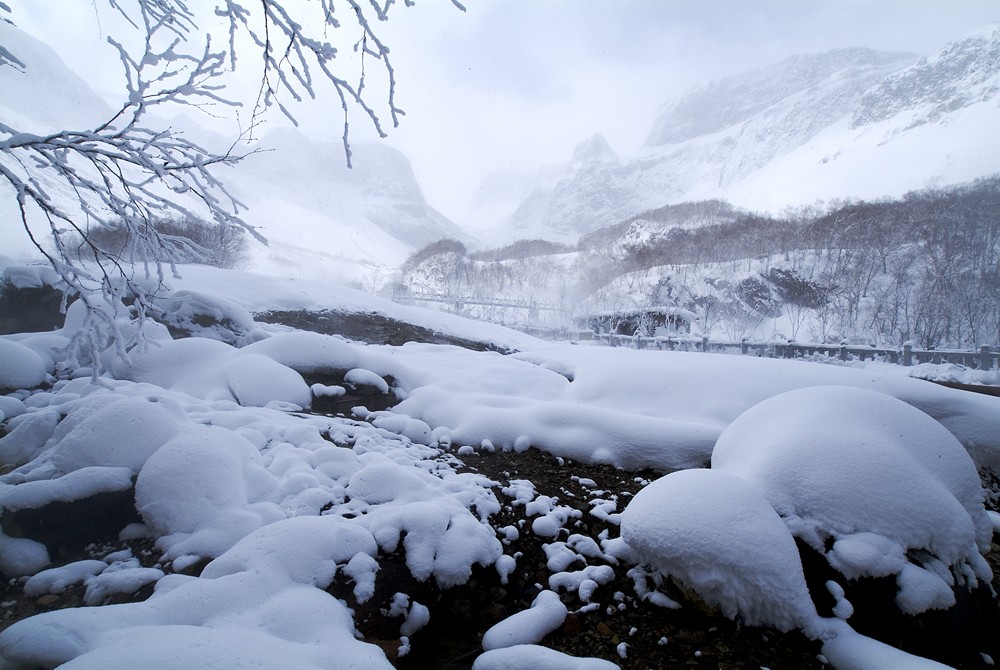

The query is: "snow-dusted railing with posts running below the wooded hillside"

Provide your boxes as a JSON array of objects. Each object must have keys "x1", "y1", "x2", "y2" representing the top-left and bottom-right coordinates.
[{"x1": 594, "y1": 333, "x2": 1000, "y2": 370}]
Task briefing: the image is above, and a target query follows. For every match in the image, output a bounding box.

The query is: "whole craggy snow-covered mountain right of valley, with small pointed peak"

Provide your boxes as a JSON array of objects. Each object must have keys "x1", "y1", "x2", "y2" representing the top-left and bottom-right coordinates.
[{"x1": 486, "y1": 25, "x2": 1000, "y2": 245}]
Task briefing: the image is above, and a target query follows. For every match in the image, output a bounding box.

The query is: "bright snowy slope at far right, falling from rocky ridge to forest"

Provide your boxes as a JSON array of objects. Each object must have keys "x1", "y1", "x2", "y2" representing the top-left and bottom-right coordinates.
[{"x1": 727, "y1": 24, "x2": 1000, "y2": 209}]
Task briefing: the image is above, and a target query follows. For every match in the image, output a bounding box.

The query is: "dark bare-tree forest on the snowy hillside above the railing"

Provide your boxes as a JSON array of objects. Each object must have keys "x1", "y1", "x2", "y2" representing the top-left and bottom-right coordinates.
[{"x1": 397, "y1": 177, "x2": 1000, "y2": 348}]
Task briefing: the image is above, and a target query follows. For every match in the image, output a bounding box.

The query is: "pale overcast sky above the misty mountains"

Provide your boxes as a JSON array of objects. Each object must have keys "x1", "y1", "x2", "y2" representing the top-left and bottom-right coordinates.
[{"x1": 10, "y1": 0, "x2": 1000, "y2": 223}]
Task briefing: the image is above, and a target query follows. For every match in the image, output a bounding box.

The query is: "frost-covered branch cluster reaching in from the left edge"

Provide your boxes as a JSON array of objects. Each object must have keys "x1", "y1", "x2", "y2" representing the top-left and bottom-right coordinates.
[{"x1": 0, "y1": 2, "x2": 250, "y2": 379}]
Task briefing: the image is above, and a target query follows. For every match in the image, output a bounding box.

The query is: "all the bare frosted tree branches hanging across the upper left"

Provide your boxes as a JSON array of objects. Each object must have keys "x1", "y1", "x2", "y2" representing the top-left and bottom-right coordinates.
[{"x1": 0, "y1": 0, "x2": 463, "y2": 380}]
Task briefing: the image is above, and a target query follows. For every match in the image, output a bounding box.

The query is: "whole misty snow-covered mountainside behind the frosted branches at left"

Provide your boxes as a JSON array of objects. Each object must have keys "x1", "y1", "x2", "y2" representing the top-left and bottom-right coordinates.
[{"x1": 0, "y1": 21, "x2": 462, "y2": 282}]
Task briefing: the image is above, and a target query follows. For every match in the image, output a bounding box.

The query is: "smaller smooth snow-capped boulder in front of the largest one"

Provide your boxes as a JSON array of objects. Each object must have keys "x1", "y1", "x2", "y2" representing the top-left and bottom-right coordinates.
[{"x1": 621, "y1": 469, "x2": 818, "y2": 630}]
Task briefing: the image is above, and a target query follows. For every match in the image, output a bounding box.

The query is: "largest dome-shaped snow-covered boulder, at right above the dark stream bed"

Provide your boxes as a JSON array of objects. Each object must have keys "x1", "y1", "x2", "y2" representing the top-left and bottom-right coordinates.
[{"x1": 712, "y1": 386, "x2": 992, "y2": 613}]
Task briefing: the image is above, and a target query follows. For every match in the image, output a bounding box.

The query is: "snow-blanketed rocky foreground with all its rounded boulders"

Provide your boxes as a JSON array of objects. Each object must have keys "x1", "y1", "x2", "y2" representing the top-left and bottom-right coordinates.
[{"x1": 0, "y1": 267, "x2": 1000, "y2": 669}]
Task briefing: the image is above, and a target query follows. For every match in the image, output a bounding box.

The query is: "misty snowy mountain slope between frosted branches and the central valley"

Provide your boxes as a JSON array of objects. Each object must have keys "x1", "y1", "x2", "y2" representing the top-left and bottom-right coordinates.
[{"x1": 228, "y1": 128, "x2": 461, "y2": 281}]
